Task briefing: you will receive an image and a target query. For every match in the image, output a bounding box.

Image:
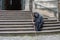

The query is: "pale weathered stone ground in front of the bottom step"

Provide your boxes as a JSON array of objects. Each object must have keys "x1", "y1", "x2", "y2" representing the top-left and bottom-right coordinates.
[{"x1": 0, "y1": 33, "x2": 60, "y2": 40}]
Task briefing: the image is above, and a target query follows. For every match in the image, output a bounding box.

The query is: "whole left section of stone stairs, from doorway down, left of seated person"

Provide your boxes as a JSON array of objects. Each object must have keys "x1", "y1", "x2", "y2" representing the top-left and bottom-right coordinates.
[{"x1": 0, "y1": 11, "x2": 35, "y2": 33}]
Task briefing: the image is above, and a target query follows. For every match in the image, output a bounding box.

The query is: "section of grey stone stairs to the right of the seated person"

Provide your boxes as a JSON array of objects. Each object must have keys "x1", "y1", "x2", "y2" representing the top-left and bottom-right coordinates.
[{"x1": 41, "y1": 17, "x2": 60, "y2": 32}]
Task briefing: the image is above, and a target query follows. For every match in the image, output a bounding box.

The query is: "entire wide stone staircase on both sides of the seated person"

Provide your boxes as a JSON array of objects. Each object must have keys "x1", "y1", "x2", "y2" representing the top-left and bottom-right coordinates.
[{"x1": 0, "y1": 11, "x2": 60, "y2": 33}]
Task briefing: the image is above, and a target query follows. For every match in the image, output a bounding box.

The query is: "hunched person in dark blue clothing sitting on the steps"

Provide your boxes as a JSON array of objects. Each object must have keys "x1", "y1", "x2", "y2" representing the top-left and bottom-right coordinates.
[{"x1": 34, "y1": 12, "x2": 43, "y2": 31}]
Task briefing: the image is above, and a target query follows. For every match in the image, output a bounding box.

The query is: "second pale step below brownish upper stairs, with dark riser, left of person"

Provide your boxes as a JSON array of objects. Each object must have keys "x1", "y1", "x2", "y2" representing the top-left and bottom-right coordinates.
[{"x1": 0, "y1": 22, "x2": 34, "y2": 25}]
